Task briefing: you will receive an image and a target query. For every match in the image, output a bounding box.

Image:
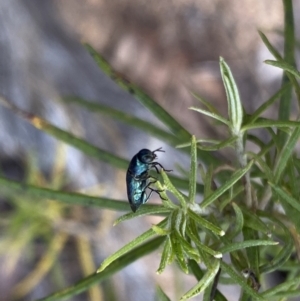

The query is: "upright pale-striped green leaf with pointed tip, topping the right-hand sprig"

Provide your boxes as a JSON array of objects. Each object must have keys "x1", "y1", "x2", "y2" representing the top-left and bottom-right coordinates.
[{"x1": 220, "y1": 57, "x2": 243, "y2": 135}]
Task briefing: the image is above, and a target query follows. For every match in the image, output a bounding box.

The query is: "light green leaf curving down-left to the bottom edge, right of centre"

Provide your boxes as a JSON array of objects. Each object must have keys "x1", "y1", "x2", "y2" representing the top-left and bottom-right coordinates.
[{"x1": 180, "y1": 259, "x2": 220, "y2": 300}]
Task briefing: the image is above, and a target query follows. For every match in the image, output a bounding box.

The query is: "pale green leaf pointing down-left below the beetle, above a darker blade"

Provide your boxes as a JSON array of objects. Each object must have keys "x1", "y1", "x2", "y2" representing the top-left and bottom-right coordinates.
[{"x1": 97, "y1": 218, "x2": 167, "y2": 273}]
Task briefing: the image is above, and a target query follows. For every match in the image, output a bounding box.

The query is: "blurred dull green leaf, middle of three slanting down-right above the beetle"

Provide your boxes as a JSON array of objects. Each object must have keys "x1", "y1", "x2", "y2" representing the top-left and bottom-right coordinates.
[{"x1": 62, "y1": 96, "x2": 179, "y2": 145}]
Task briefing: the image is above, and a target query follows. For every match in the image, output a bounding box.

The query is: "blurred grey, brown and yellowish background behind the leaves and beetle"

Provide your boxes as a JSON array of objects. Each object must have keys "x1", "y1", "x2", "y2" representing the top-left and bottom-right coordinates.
[{"x1": 0, "y1": 0, "x2": 300, "y2": 301}]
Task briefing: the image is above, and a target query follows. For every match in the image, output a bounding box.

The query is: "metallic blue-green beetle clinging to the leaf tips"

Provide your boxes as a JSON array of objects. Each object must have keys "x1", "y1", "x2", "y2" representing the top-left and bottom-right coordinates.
[{"x1": 126, "y1": 147, "x2": 170, "y2": 212}]
